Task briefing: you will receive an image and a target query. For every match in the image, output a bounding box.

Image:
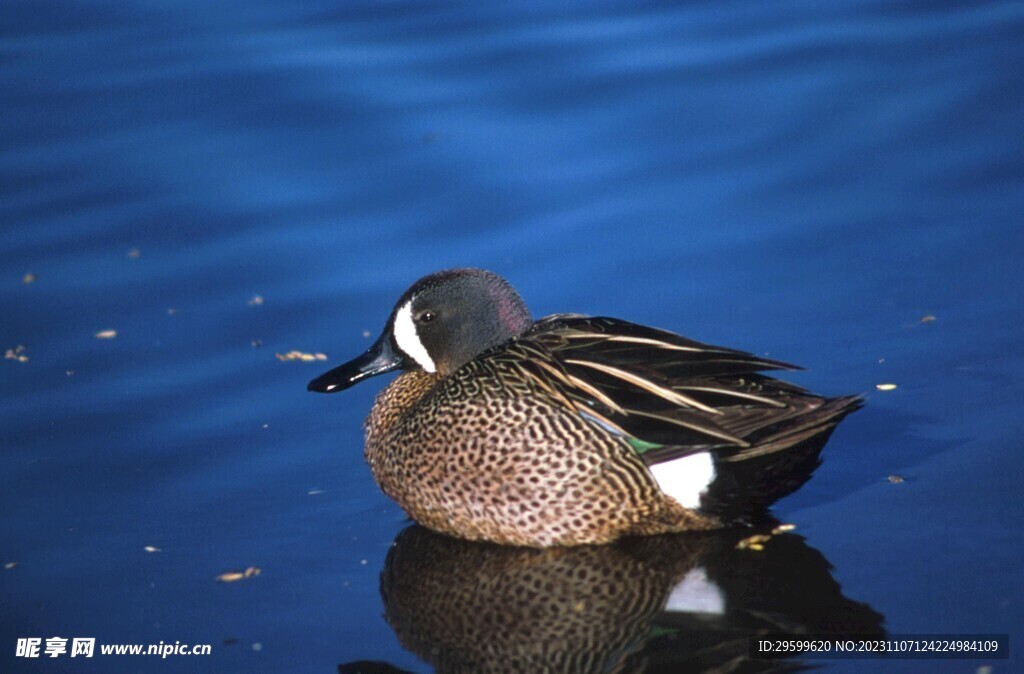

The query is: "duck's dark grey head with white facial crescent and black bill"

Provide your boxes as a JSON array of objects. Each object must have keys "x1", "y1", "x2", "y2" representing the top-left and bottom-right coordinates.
[{"x1": 306, "y1": 268, "x2": 534, "y2": 393}]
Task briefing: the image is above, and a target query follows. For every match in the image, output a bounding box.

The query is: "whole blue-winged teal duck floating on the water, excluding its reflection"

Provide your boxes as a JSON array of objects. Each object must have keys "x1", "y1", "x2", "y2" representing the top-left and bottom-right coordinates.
[{"x1": 308, "y1": 269, "x2": 860, "y2": 547}]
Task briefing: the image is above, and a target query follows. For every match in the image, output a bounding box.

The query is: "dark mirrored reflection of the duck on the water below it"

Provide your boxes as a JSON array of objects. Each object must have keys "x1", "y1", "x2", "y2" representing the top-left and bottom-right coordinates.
[{"x1": 339, "y1": 525, "x2": 883, "y2": 673}]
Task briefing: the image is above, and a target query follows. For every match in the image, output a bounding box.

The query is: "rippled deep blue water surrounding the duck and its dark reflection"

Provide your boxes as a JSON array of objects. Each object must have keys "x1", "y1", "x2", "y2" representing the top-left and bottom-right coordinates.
[{"x1": 0, "y1": 0, "x2": 1024, "y2": 672}]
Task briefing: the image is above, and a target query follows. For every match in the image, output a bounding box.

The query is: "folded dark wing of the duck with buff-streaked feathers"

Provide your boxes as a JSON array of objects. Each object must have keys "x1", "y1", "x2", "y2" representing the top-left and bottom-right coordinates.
[{"x1": 502, "y1": 314, "x2": 839, "y2": 456}]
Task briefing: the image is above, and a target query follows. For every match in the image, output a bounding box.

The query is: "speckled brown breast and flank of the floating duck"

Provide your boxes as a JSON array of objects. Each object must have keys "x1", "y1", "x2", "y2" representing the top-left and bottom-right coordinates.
[{"x1": 366, "y1": 359, "x2": 717, "y2": 546}]
